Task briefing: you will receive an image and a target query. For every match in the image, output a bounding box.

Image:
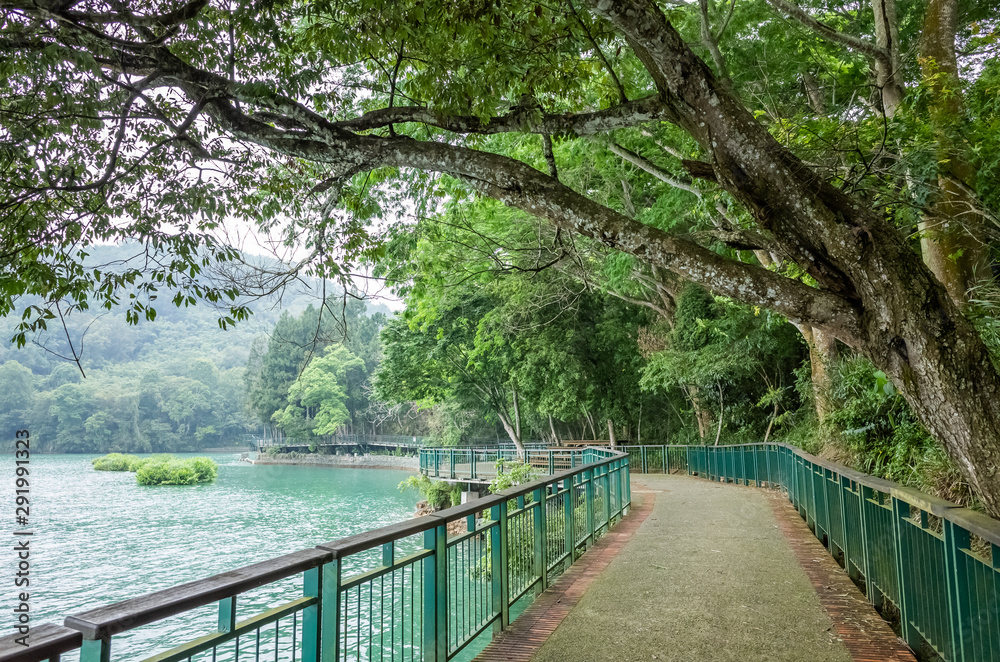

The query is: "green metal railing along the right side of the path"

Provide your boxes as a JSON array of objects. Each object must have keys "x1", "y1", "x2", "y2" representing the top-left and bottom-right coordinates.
[{"x1": 620, "y1": 443, "x2": 1000, "y2": 662}]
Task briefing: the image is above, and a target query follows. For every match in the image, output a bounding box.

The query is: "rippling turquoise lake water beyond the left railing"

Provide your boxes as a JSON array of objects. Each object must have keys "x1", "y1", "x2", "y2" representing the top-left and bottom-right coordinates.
[{"x1": 12, "y1": 454, "x2": 419, "y2": 659}]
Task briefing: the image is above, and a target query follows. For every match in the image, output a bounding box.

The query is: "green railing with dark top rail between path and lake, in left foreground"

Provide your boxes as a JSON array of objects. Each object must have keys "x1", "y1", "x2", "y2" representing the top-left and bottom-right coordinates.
[{"x1": 0, "y1": 451, "x2": 631, "y2": 662}]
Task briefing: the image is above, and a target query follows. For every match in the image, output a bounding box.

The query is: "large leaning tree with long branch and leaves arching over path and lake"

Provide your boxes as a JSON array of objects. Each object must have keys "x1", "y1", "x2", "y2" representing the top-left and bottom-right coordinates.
[{"x1": 0, "y1": 0, "x2": 1000, "y2": 514}]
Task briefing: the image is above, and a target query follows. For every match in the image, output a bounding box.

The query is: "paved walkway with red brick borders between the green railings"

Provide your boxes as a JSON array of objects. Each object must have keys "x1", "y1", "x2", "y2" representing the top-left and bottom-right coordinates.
[{"x1": 482, "y1": 475, "x2": 913, "y2": 662}]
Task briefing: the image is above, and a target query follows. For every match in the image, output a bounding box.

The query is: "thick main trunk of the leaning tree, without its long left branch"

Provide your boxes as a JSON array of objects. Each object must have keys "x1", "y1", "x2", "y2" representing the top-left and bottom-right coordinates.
[{"x1": 592, "y1": 0, "x2": 1000, "y2": 515}]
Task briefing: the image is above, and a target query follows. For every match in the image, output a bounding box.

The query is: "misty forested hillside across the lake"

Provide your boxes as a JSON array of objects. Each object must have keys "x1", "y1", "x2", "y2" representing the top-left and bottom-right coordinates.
[{"x1": 0, "y1": 245, "x2": 390, "y2": 453}]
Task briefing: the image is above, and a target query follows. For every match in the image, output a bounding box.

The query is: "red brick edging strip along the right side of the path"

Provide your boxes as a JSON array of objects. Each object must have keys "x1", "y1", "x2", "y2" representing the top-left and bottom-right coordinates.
[{"x1": 770, "y1": 494, "x2": 916, "y2": 662}]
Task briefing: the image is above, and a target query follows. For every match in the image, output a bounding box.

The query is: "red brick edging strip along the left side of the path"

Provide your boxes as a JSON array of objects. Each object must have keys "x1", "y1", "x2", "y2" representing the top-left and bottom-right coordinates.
[{"x1": 475, "y1": 490, "x2": 662, "y2": 662}]
